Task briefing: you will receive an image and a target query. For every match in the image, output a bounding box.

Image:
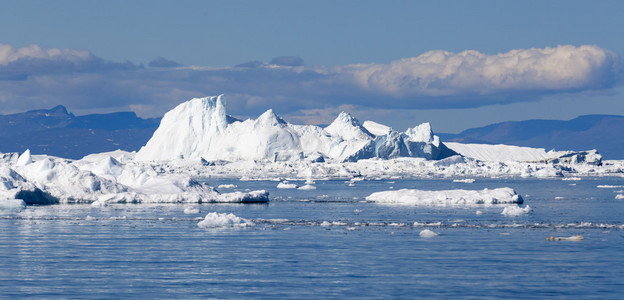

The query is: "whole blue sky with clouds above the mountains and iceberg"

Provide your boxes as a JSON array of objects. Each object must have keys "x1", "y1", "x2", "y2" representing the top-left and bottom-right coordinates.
[{"x1": 0, "y1": 0, "x2": 624, "y2": 133}]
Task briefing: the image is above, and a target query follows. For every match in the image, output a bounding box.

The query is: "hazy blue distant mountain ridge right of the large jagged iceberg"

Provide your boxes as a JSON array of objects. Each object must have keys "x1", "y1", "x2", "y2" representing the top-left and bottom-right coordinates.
[{"x1": 438, "y1": 115, "x2": 624, "y2": 159}]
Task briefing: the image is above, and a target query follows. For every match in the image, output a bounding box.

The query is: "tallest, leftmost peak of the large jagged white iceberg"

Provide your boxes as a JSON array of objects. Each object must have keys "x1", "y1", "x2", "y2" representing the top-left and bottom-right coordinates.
[{"x1": 136, "y1": 95, "x2": 228, "y2": 161}]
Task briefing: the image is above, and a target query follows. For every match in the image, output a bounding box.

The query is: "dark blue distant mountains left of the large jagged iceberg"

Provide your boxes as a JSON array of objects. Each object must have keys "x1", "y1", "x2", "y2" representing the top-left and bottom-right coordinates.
[{"x1": 0, "y1": 105, "x2": 160, "y2": 159}]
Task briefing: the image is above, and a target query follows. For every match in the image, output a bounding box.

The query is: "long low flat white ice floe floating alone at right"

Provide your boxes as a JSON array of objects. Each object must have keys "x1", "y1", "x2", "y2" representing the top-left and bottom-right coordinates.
[{"x1": 366, "y1": 188, "x2": 523, "y2": 206}]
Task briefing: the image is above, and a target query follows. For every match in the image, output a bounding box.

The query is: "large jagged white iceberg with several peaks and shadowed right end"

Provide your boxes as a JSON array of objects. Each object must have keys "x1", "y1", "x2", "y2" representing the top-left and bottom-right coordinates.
[{"x1": 136, "y1": 95, "x2": 456, "y2": 162}]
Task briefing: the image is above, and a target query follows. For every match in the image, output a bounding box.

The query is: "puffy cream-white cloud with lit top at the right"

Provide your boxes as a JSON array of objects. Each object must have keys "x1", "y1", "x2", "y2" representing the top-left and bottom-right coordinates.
[{"x1": 347, "y1": 45, "x2": 617, "y2": 98}]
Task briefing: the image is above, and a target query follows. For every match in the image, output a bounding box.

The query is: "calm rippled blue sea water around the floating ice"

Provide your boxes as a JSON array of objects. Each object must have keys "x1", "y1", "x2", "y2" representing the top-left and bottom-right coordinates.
[{"x1": 0, "y1": 177, "x2": 624, "y2": 299}]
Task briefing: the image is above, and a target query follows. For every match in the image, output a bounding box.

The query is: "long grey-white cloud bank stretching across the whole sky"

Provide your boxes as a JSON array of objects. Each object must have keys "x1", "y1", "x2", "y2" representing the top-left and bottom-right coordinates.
[{"x1": 0, "y1": 44, "x2": 621, "y2": 119}]
